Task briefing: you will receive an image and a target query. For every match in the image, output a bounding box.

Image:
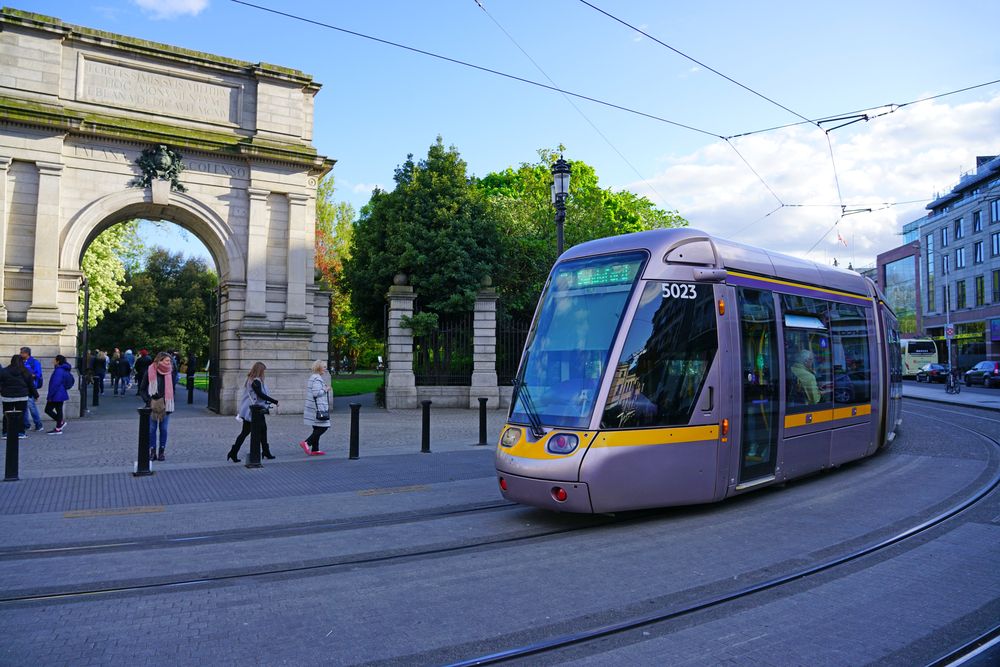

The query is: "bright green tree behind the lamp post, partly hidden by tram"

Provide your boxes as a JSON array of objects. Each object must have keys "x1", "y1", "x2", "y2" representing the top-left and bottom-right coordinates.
[{"x1": 476, "y1": 147, "x2": 687, "y2": 317}]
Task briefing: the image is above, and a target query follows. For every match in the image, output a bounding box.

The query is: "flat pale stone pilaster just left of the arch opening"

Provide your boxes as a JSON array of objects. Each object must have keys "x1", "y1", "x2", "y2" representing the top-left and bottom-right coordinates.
[{"x1": 28, "y1": 162, "x2": 63, "y2": 323}]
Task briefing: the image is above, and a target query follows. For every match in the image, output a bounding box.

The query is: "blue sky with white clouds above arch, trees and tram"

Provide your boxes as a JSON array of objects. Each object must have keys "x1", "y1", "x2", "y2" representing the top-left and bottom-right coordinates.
[{"x1": 23, "y1": 0, "x2": 1000, "y2": 266}]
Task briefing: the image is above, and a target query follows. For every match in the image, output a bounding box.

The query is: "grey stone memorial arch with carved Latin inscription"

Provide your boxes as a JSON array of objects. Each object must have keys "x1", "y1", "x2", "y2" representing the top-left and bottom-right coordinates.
[{"x1": 0, "y1": 8, "x2": 333, "y2": 414}]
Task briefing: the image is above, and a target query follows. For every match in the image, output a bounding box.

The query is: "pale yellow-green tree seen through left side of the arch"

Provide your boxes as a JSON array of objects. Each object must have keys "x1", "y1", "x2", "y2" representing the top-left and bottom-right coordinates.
[{"x1": 77, "y1": 220, "x2": 144, "y2": 328}]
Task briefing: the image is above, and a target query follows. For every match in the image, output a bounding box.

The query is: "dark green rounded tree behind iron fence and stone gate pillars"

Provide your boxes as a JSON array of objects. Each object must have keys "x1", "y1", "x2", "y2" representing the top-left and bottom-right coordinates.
[{"x1": 344, "y1": 137, "x2": 498, "y2": 335}]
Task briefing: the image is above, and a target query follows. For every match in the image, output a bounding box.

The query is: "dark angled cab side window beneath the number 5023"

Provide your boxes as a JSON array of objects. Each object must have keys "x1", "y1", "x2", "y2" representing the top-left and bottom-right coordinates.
[{"x1": 601, "y1": 282, "x2": 719, "y2": 428}]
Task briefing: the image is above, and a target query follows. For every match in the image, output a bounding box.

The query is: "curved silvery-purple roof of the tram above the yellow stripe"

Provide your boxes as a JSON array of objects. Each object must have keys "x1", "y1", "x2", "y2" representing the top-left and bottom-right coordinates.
[{"x1": 560, "y1": 227, "x2": 876, "y2": 295}]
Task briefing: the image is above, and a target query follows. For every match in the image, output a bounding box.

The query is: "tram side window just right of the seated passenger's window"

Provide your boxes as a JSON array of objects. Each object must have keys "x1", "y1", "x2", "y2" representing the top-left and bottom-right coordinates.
[{"x1": 830, "y1": 303, "x2": 872, "y2": 405}]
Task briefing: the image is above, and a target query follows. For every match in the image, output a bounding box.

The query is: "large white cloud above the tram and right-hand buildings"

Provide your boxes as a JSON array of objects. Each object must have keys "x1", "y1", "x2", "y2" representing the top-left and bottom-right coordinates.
[{"x1": 629, "y1": 95, "x2": 1000, "y2": 267}]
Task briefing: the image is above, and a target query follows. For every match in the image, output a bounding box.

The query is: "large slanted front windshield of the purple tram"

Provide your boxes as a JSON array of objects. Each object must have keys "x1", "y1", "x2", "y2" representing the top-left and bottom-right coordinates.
[{"x1": 510, "y1": 252, "x2": 647, "y2": 428}]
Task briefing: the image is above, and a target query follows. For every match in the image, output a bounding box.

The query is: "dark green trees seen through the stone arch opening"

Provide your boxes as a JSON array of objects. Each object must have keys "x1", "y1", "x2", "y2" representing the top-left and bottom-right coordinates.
[{"x1": 91, "y1": 248, "x2": 218, "y2": 359}]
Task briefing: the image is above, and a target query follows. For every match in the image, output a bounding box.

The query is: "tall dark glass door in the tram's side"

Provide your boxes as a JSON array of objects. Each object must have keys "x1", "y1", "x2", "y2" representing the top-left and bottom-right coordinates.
[{"x1": 736, "y1": 287, "x2": 781, "y2": 482}]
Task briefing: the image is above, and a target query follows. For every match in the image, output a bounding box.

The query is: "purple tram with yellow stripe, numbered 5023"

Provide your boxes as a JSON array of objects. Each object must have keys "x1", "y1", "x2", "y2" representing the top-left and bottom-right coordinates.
[{"x1": 496, "y1": 228, "x2": 902, "y2": 513}]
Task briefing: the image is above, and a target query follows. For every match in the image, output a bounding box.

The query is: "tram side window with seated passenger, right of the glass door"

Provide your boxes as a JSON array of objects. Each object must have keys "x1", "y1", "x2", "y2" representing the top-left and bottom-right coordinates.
[{"x1": 781, "y1": 294, "x2": 833, "y2": 412}]
